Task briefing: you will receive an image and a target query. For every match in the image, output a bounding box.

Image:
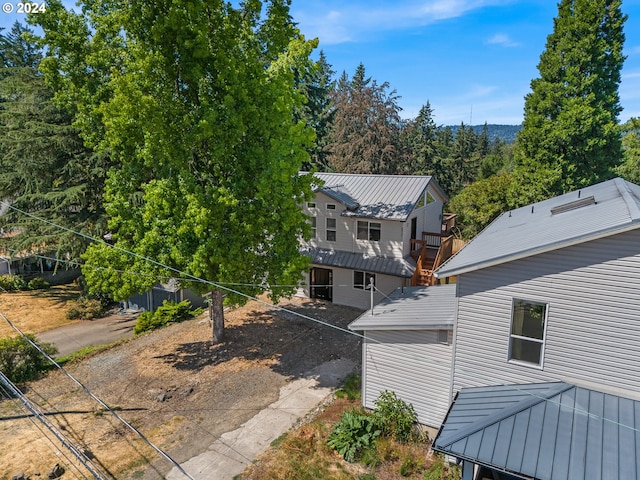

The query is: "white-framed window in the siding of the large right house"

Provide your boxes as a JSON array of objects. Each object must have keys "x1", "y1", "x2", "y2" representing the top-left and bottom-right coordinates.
[{"x1": 509, "y1": 299, "x2": 548, "y2": 366}]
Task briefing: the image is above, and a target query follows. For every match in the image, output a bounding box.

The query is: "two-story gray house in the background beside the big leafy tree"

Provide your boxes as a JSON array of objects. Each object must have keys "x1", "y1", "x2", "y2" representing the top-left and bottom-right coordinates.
[{"x1": 302, "y1": 173, "x2": 447, "y2": 308}]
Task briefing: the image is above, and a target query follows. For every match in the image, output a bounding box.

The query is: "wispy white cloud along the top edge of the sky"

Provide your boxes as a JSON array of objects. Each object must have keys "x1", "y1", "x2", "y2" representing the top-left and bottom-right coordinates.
[{"x1": 291, "y1": 0, "x2": 514, "y2": 44}]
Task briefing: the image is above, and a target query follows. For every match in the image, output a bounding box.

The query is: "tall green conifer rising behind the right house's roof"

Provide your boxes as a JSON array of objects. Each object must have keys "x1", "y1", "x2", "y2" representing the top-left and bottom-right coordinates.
[{"x1": 511, "y1": 0, "x2": 626, "y2": 206}]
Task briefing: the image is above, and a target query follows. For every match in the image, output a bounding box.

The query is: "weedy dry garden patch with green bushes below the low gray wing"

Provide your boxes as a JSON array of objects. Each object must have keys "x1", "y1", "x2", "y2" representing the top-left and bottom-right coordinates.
[{"x1": 244, "y1": 375, "x2": 461, "y2": 480}]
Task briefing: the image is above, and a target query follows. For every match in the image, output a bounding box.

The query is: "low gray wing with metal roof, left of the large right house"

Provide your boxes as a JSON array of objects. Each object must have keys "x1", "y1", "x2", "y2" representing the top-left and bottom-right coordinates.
[{"x1": 349, "y1": 285, "x2": 456, "y2": 428}]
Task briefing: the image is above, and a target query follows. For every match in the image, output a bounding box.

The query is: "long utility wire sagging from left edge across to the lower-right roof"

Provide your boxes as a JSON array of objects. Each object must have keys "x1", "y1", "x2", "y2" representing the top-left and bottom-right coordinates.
[{"x1": 5, "y1": 201, "x2": 640, "y2": 432}]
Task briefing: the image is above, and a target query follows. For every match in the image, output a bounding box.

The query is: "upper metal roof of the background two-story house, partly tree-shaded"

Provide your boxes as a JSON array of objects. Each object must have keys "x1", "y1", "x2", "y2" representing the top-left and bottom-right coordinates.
[{"x1": 306, "y1": 172, "x2": 447, "y2": 221}]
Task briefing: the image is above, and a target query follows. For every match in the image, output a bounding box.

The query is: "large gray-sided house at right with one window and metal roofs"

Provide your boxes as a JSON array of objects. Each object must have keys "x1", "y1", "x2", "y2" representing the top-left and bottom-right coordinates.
[{"x1": 348, "y1": 178, "x2": 640, "y2": 480}]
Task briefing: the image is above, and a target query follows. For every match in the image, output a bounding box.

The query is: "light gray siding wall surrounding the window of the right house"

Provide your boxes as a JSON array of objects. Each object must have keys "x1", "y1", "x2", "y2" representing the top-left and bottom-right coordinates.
[{"x1": 454, "y1": 230, "x2": 640, "y2": 394}]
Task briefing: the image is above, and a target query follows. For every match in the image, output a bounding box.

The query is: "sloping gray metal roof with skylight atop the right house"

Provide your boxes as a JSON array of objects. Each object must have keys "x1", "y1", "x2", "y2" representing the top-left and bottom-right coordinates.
[{"x1": 435, "y1": 178, "x2": 640, "y2": 278}]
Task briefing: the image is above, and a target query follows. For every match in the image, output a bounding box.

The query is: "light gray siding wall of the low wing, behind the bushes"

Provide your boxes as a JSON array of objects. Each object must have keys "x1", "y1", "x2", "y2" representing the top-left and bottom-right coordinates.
[{"x1": 362, "y1": 330, "x2": 453, "y2": 428}]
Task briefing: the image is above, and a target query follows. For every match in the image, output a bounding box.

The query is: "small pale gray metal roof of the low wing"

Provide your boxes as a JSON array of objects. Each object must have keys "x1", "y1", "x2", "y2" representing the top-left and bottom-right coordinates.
[{"x1": 349, "y1": 284, "x2": 457, "y2": 330}]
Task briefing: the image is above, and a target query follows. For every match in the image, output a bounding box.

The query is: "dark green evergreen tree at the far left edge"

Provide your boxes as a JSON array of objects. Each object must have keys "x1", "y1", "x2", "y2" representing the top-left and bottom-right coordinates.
[{"x1": 0, "y1": 23, "x2": 108, "y2": 260}]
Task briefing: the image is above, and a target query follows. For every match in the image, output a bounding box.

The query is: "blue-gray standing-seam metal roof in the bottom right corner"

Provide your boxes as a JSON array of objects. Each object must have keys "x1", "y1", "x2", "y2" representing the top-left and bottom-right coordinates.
[{"x1": 432, "y1": 382, "x2": 640, "y2": 480}]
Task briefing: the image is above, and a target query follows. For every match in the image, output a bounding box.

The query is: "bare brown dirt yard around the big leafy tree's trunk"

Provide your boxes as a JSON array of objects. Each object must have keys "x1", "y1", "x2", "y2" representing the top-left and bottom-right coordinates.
[{"x1": 0, "y1": 296, "x2": 361, "y2": 480}]
